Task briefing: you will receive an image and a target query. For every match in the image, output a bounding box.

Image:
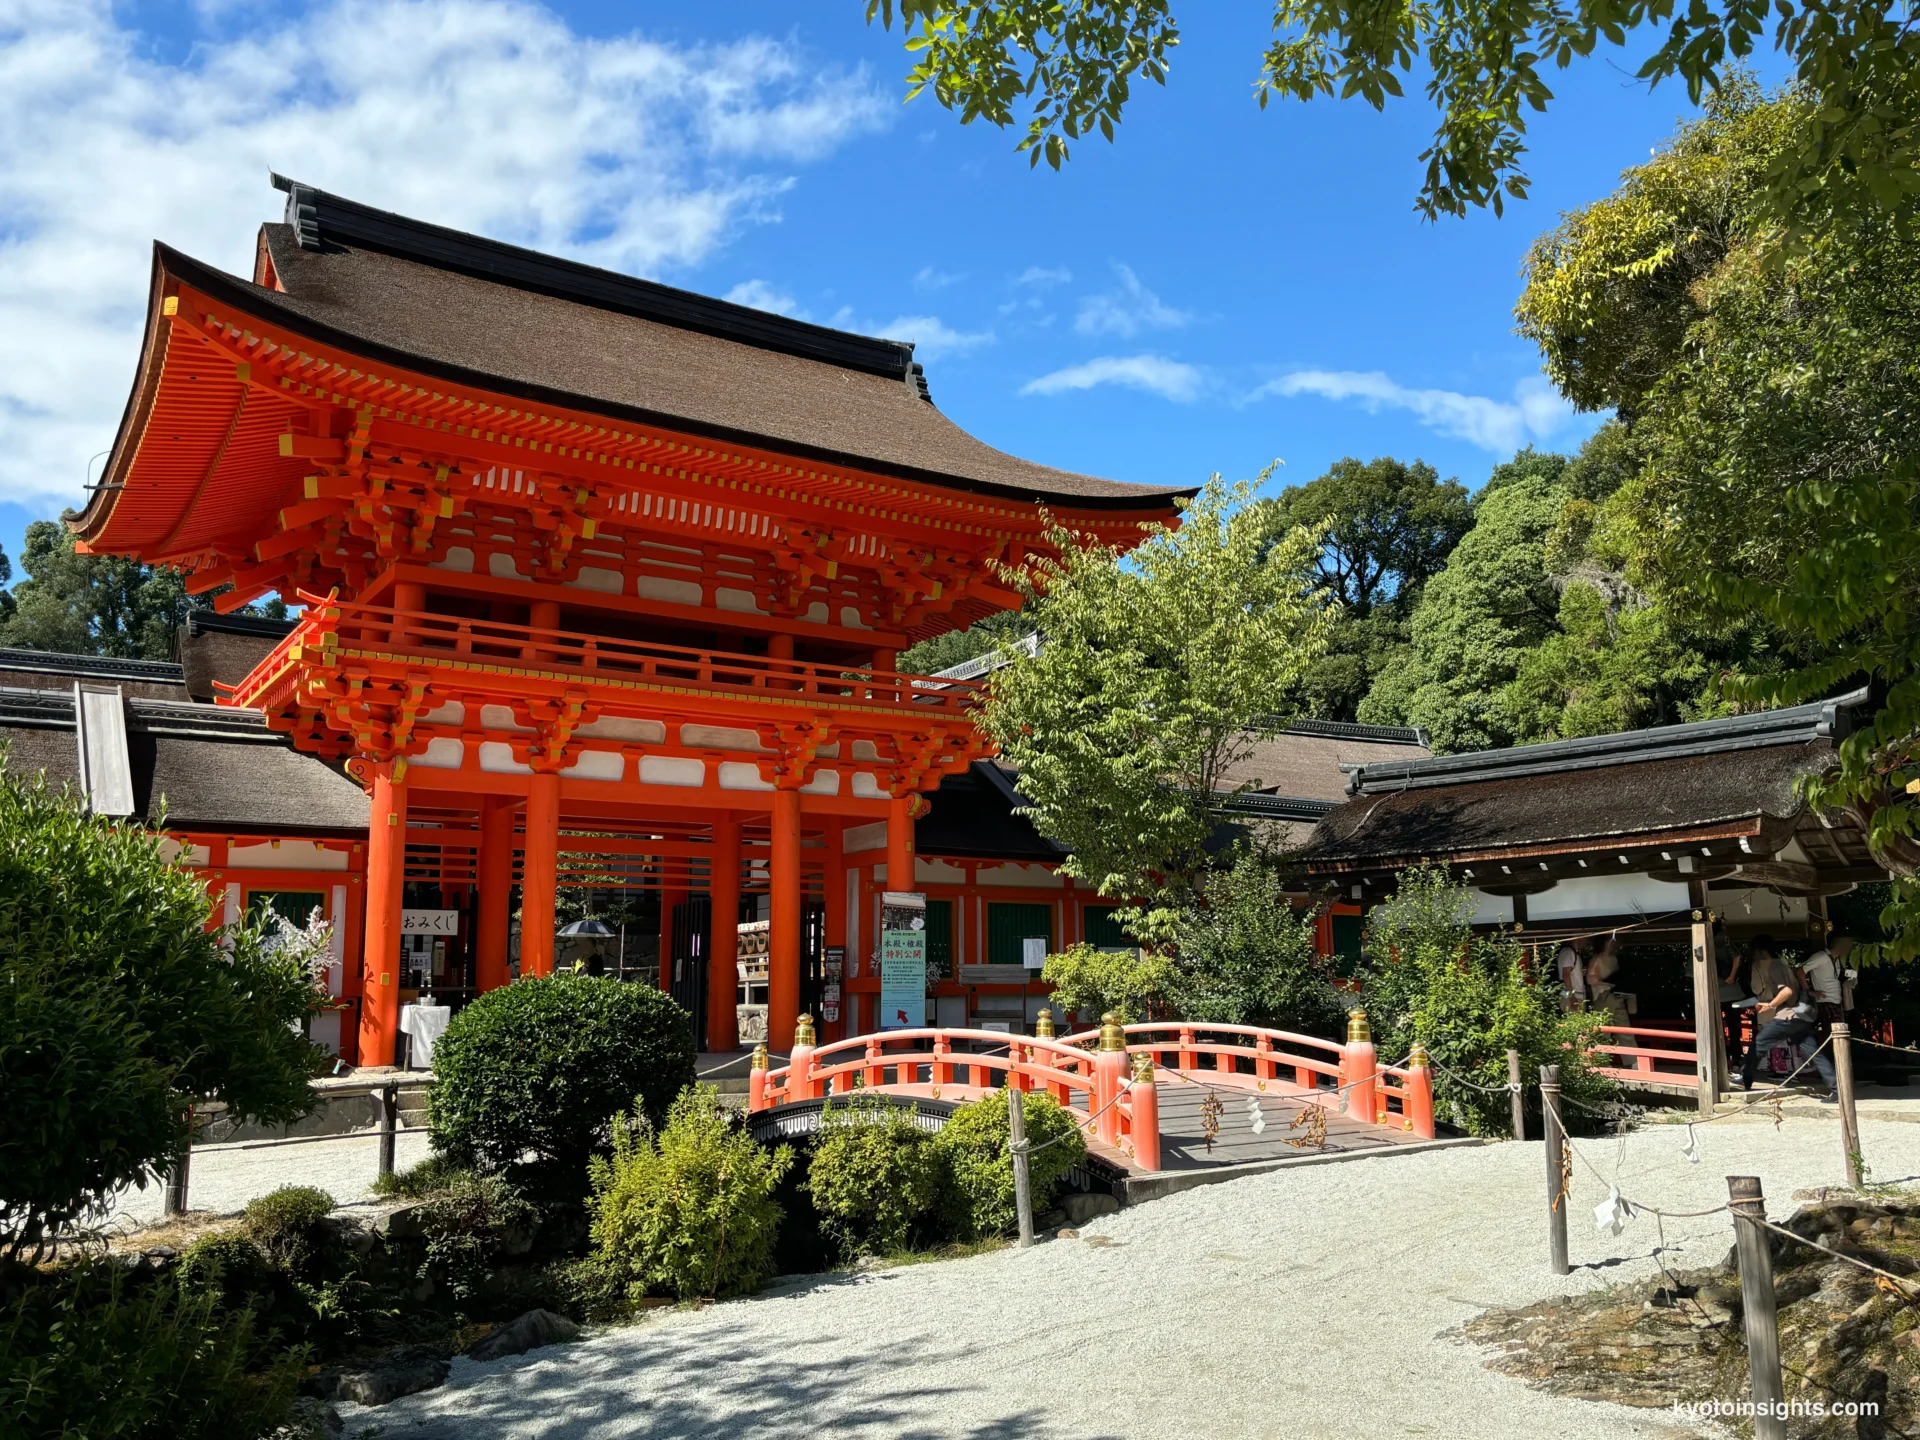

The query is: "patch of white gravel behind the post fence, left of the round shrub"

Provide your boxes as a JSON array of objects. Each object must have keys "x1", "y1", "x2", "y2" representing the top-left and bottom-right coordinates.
[{"x1": 108, "y1": 1129, "x2": 428, "y2": 1229}]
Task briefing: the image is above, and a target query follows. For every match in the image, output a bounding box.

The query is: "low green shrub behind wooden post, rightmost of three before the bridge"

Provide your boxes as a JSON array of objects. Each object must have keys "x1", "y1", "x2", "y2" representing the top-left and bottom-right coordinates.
[{"x1": 933, "y1": 1091, "x2": 1087, "y2": 1240}]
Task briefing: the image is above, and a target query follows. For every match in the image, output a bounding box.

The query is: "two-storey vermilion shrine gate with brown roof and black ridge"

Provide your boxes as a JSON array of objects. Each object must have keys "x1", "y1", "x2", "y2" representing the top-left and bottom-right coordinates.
[{"x1": 74, "y1": 177, "x2": 1205, "y2": 1064}]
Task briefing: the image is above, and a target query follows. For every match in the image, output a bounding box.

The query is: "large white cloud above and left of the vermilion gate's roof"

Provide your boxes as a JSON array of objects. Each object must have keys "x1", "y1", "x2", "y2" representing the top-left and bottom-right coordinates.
[{"x1": 0, "y1": 0, "x2": 897, "y2": 509}]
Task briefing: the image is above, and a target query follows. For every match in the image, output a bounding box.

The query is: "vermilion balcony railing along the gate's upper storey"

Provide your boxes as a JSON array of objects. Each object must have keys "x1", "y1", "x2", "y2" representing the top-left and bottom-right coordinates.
[{"x1": 232, "y1": 601, "x2": 981, "y2": 716}]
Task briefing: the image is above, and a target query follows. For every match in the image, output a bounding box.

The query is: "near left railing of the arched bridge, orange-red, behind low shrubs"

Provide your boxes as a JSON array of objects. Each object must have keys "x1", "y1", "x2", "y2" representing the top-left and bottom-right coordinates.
[{"x1": 747, "y1": 1029, "x2": 1160, "y2": 1171}]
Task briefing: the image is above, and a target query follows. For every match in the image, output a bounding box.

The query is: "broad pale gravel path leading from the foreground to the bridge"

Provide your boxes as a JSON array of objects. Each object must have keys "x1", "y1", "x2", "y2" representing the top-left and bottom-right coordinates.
[{"x1": 344, "y1": 1117, "x2": 1920, "y2": 1440}]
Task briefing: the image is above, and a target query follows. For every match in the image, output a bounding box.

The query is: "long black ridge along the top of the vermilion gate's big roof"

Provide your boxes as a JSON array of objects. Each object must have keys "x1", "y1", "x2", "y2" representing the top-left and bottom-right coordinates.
[{"x1": 269, "y1": 175, "x2": 918, "y2": 384}]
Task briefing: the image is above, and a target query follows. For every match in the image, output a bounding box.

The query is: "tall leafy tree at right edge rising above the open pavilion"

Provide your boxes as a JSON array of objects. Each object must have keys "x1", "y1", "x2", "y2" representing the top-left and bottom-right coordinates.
[{"x1": 1521, "y1": 81, "x2": 1920, "y2": 958}]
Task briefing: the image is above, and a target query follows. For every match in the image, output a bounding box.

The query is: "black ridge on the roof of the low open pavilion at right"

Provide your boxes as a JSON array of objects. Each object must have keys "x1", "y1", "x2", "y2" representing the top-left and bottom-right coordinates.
[{"x1": 1346, "y1": 687, "x2": 1868, "y2": 795}]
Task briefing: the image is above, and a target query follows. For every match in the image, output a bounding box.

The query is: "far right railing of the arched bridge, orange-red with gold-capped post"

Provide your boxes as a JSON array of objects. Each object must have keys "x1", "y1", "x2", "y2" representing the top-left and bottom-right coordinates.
[{"x1": 1062, "y1": 1010, "x2": 1434, "y2": 1140}]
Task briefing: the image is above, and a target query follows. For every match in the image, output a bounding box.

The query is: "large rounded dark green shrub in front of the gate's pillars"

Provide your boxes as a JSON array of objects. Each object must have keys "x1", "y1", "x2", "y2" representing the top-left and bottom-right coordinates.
[{"x1": 426, "y1": 973, "x2": 693, "y2": 1196}]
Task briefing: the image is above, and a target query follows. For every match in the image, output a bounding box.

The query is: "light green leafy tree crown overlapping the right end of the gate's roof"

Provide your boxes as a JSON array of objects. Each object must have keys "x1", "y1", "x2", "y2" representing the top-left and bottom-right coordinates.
[{"x1": 981, "y1": 480, "x2": 1327, "y2": 913}]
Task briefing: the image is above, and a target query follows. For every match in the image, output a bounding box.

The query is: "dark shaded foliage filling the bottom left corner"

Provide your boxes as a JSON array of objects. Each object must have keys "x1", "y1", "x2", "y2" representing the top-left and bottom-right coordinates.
[{"x1": 0, "y1": 1261, "x2": 305, "y2": 1440}]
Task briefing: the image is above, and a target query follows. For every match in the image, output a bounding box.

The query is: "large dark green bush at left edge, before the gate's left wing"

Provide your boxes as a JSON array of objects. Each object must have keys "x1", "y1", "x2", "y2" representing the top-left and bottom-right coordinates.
[{"x1": 0, "y1": 764, "x2": 321, "y2": 1254}]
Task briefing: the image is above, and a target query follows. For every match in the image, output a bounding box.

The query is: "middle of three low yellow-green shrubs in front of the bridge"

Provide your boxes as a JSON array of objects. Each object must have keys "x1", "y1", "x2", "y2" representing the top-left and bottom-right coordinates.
[{"x1": 806, "y1": 1094, "x2": 945, "y2": 1260}]
